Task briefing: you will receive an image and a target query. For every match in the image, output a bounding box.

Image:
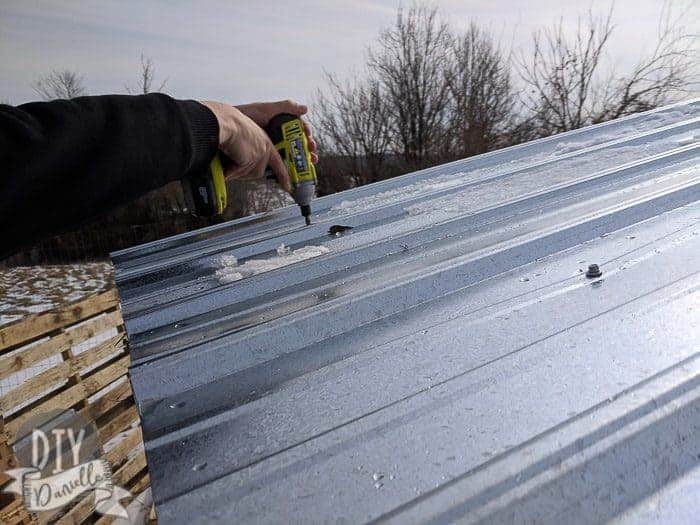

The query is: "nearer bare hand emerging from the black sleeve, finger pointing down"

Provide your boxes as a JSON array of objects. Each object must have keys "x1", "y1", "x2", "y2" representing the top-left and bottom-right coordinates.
[{"x1": 202, "y1": 101, "x2": 292, "y2": 192}]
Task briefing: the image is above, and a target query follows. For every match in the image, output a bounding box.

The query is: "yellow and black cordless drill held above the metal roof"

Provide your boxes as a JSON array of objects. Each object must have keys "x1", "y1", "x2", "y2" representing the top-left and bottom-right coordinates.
[{"x1": 183, "y1": 113, "x2": 316, "y2": 225}]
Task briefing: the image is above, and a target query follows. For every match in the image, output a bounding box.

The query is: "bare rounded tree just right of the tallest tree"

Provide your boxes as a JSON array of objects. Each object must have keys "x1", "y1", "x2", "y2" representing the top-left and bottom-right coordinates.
[{"x1": 445, "y1": 24, "x2": 515, "y2": 158}]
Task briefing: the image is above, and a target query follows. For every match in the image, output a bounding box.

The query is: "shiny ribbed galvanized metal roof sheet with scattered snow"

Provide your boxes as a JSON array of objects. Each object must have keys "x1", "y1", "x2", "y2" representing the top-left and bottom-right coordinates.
[{"x1": 113, "y1": 100, "x2": 700, "y2": 523}]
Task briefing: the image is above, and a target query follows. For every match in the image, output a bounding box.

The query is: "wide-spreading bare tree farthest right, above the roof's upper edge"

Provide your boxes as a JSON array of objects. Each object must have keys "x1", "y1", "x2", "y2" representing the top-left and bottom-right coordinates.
[{"x1": 518, "y1": 7, "x2": 692, "y2": 135}]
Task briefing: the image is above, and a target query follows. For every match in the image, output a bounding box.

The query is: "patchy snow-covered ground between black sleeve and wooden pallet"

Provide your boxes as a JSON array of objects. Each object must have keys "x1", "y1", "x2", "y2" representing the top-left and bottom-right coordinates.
[{"x1": 0, "y1": 262, "x2": 114, "y2": 326}]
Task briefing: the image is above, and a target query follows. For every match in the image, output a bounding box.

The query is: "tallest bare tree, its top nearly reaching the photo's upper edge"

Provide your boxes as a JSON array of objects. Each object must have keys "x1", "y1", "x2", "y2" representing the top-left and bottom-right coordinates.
[{"x1": 369, "y1": 4, "x2": 452, "y2": 168}]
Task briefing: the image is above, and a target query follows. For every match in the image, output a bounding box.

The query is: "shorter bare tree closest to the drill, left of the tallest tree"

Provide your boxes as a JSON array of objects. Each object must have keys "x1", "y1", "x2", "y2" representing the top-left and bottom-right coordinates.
[{"x1": 315, "y1": 75, "x2": 391, "y2": 191}]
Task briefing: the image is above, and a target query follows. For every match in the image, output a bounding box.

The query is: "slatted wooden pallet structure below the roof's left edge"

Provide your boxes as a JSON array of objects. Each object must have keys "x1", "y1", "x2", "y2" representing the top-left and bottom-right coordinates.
[{"x1": 0, "y1": 289, "x2": 149, "y2": 524}]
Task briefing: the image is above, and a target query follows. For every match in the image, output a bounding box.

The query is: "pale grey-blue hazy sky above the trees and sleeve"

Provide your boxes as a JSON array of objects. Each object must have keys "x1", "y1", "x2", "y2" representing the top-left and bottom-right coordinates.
[{"x1": 0, "y1": 0, "x2": 700, "y2": 104}]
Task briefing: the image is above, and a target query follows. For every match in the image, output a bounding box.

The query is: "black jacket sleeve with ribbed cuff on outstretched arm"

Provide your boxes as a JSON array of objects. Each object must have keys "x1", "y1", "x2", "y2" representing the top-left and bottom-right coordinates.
[{"x1": 0, "y1": 94, "x2": 219, "y2": 256}]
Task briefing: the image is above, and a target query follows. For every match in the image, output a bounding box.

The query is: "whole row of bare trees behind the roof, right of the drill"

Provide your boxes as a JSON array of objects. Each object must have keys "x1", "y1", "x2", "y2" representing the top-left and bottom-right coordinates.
[{"x1": 313, "y1": 2, "x2": 698, "y2": 193}]
